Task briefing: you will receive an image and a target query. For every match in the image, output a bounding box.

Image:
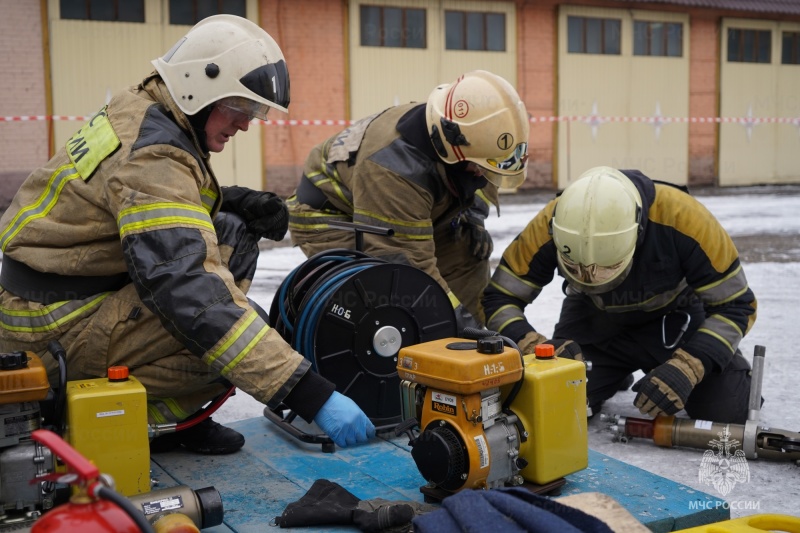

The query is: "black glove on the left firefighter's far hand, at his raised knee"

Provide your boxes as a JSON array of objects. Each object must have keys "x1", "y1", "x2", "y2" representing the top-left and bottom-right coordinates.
[{"x1": 222, "y1": 187, "x2": 289, "y2": 241}]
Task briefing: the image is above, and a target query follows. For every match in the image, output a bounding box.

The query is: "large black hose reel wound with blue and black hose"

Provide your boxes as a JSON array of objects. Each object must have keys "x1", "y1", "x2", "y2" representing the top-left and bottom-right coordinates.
[{"x1": 265, "y1": 249, "x2": 456, "y2": 429}]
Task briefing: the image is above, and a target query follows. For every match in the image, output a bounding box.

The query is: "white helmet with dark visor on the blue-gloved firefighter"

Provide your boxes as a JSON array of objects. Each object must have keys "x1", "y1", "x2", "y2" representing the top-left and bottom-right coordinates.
[{"x1": 152, "y1": 15, "x2": 289, "y2": 120}]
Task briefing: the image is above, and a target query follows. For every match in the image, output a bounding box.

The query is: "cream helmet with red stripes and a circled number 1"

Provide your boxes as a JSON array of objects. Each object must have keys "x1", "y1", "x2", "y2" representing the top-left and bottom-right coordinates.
[{"x1": 425, "y1": 70, "x2": 530, "y2": 188}]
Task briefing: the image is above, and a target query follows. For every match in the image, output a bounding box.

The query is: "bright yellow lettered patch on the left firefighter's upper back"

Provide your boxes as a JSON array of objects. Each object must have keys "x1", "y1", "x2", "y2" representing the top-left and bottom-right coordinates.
[{"x1": 65, "y1": 106, "x2": 121, "y2": 180}]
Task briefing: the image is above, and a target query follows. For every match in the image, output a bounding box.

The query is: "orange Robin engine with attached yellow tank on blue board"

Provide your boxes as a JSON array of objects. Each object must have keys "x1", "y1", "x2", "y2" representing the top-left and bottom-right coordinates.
[{"x1": 396, "y1": 337, "x2": 588, "y2": 497}]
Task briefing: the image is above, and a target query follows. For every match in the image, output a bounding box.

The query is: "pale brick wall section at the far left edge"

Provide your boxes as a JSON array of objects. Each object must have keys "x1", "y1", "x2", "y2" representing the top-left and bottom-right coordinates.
[{"x1": 0, "y1": 0, "x2": 49, "y2": 211}]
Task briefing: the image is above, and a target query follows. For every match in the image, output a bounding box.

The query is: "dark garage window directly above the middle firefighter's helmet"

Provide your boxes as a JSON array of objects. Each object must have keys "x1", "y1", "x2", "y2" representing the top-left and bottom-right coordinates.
[{"x1": 444, "y1": 11, "x2": 506, "y2": 52}]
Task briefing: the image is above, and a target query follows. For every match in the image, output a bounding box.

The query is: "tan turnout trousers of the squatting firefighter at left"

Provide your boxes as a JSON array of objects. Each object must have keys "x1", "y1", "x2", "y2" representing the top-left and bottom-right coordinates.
[{"x1": 0, "y1": 213, "x2": 266, "y2": 423}]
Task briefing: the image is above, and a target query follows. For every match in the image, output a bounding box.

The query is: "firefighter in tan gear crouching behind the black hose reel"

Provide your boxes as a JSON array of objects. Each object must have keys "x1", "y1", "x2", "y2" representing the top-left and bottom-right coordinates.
[{"x1": 287, "y1": 70, "x2": 529, "y2": 327}]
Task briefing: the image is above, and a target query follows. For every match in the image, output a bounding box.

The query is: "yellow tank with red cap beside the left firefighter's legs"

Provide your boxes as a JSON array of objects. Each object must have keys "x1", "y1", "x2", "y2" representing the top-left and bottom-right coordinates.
[{"x1": 66, "y1": 367, "x2": 150, "y2": 496}]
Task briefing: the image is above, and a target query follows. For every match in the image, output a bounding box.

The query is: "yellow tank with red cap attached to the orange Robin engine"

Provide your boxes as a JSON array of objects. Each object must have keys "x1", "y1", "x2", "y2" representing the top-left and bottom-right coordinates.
[{"x1": 505, "y1": 345, "x2": 589, "y2": 484}]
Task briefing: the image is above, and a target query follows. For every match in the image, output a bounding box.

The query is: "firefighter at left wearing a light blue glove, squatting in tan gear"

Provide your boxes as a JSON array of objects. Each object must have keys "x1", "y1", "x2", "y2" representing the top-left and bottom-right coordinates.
[{"x1": 0, "y1": 15, "x2": 374, "y2": 453}]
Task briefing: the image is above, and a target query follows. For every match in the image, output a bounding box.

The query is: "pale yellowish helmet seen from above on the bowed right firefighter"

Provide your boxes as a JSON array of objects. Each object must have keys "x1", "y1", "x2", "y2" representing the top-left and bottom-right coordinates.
[{"x1": 552, "y1": 167, "x2": 642, "y2": 294}]
